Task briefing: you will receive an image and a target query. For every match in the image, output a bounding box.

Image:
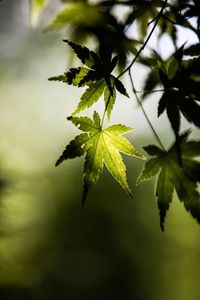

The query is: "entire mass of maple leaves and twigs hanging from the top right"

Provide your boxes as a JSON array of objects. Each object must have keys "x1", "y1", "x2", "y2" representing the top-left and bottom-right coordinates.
[{"x1": 32, "y1": 0, "x2": 200, "y2": 230}]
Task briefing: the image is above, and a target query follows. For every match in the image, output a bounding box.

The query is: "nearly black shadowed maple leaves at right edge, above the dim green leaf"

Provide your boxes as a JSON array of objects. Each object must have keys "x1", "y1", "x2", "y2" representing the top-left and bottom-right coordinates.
[{"x1": 143, "y1": 45, "x2": 200, "y2": 139}]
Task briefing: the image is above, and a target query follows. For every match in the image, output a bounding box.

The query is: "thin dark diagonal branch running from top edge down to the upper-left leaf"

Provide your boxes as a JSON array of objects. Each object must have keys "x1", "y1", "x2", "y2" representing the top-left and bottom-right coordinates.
[{"x1": 117, "y1": 0, "x2": 168, "y2": 78}]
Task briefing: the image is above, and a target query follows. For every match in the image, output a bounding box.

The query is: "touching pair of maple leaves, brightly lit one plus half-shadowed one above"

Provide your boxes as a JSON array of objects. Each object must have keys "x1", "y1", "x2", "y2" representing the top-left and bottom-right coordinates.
[{"x1": 49, "y1": 40, "x2": 144, "y2": 203}]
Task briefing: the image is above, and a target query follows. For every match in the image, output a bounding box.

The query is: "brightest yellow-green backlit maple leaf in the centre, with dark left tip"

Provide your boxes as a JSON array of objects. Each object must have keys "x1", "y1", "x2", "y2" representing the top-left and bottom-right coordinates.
[{"x1": 56, "y1": 111, "x2": 144, "y2": 203}]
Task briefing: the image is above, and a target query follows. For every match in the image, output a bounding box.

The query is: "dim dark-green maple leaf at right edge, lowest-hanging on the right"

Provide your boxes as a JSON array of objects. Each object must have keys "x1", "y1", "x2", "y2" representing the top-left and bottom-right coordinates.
[{"x1": 137, "y1": 132, "x2": 200, "y2": 230}]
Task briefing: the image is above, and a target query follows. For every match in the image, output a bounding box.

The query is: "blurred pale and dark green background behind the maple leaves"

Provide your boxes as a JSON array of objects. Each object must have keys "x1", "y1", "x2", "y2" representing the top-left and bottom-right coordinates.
[{"x1": 0, "y1": 0, "x2": 200, "y2": 300}]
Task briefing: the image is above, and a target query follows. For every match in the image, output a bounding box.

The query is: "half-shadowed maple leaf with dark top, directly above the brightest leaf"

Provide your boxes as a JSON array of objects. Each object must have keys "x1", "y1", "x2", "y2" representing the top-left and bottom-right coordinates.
[{"x1": 49, "y1": 40, "x2": 129, "y2": 120}]
